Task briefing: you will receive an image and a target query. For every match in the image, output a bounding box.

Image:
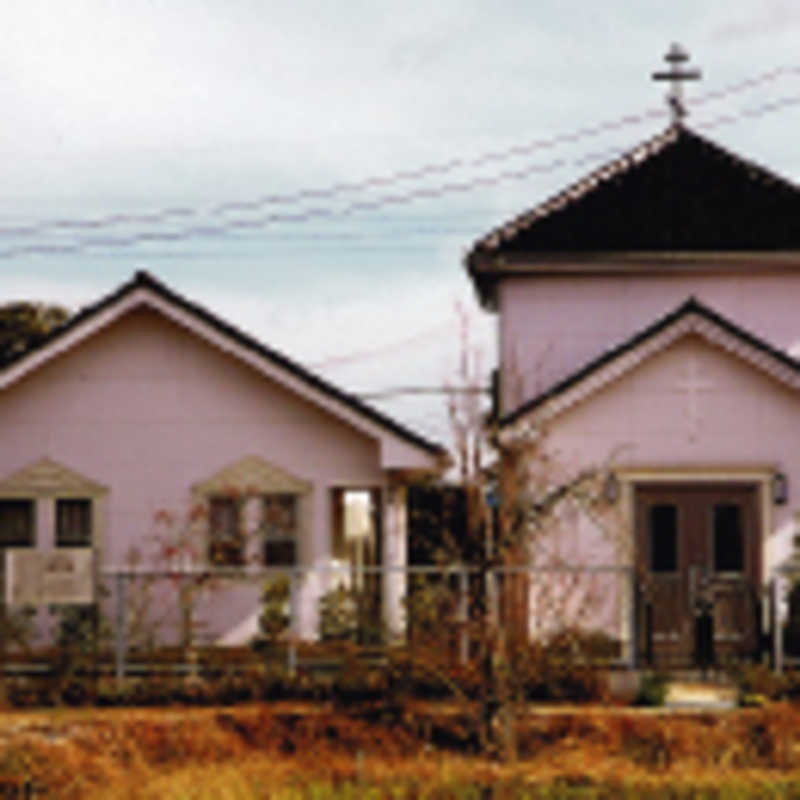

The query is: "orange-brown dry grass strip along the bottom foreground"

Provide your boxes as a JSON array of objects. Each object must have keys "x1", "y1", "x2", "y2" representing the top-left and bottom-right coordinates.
[{"x1": 0, "y1": 704, "x2": 800, "y2": 800}]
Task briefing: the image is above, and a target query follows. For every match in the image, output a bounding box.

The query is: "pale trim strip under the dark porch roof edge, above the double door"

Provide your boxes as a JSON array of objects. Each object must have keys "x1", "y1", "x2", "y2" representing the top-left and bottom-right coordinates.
[{"x1": 503, "y1": 311, "x2": 800, "y2": 439}]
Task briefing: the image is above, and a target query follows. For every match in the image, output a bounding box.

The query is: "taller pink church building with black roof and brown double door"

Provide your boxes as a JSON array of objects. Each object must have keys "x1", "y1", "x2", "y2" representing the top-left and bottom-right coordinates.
[{"x1": 466, "y1": 118, "x2": 800, "y2": 667}]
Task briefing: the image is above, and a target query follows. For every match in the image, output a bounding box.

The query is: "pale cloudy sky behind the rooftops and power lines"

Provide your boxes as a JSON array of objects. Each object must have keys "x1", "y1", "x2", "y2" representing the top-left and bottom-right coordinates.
[{"x1": 0, "y1": 0, "x2": 800, "y2": 443}]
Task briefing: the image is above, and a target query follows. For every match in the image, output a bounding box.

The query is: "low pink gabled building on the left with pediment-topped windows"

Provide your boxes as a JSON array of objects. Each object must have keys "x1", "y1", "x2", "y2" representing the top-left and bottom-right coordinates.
[{"x1": 0, "y1": 272, "x2": 446, "y2": 643}]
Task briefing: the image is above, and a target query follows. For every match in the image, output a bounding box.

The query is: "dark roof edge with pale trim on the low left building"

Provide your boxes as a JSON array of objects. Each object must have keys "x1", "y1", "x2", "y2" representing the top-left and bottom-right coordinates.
[{"x1": 0, "y1": 271, "x2": 446, "y2": 459}]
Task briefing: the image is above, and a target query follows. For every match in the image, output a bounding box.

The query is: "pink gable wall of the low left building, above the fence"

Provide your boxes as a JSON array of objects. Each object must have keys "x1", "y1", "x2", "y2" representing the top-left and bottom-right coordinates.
[{"x1": 0, "y1": 310, "x2": 384, "y2": 564}]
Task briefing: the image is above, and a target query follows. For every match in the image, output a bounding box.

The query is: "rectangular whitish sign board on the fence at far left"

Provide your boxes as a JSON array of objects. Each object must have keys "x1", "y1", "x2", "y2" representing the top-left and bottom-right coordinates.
[{"x1": 5, "y1": 547, "x2": 94, "y2": 606}]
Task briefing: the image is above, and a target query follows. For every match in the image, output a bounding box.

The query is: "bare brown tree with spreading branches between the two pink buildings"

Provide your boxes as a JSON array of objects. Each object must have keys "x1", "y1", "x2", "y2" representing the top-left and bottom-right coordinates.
[{"x1": 410, "y1": 308, "x2": 621, "y2": 760}]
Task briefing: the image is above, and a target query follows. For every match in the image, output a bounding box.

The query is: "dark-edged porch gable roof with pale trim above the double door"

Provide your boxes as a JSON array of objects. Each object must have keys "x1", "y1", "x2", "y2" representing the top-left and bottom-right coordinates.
[{"x1": 499, "y1": 297, "x2": 800, "y2": 428}]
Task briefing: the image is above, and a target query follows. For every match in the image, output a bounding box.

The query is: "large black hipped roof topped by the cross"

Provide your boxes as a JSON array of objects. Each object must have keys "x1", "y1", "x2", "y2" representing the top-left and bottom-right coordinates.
[{"x1": 466, "y1": 123, "x2": 800, "y2": 303}]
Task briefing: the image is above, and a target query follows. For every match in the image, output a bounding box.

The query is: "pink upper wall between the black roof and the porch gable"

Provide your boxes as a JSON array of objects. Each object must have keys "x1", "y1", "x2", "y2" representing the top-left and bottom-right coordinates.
[{"x1": 498, "y1": 267, "x2": 800, "y2": 411}]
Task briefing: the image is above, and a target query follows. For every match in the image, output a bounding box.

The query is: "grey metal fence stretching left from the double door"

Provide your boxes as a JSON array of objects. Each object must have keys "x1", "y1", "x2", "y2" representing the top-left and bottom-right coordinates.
[{"x1": 0, "y1": 564, "x2": 636, "y2": 679}]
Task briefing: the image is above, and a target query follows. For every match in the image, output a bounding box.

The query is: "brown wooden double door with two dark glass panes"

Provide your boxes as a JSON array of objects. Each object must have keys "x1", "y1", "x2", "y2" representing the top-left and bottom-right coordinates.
[{"x1": 635, "y1": 483, "x2": 762, "y2": 668}]
